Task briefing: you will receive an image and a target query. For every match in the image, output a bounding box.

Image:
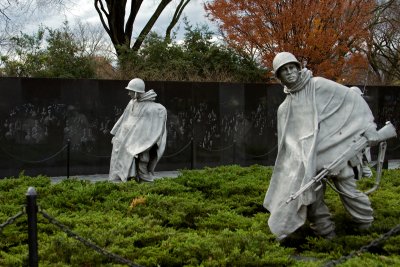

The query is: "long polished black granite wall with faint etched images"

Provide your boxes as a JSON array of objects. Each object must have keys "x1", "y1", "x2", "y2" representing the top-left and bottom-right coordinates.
[{"x1": 0, "y1": 78, "x2": 400, "y2": 177}]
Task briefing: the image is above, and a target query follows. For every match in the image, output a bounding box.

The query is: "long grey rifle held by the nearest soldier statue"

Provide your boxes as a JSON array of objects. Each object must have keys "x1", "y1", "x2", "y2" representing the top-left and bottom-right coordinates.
[{"x1": 286, "y1": 121, "x2": 397, "y2": 204}]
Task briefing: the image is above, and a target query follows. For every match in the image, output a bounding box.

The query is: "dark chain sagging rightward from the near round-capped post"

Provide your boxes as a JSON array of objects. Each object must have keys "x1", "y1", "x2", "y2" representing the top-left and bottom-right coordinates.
[{"x1": 38, "y1": 208, "x2": 142, "y2": 267}]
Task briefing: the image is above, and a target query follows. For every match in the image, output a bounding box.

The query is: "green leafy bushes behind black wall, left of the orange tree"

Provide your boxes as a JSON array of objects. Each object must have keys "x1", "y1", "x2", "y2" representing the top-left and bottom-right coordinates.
[{"x1": 1, "y1": 19, "x2": 265, "y2": 82}]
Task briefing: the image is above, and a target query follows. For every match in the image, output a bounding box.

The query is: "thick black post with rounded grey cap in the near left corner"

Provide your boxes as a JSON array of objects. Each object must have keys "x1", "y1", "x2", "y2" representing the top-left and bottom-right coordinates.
[{"x1": 26, "y1": 187, "x2": 38, "y2": 267}]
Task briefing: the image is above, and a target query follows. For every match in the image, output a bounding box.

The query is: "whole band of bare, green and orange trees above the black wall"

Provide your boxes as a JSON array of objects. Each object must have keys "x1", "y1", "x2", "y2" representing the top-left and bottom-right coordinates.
[{"x1": 0, "y1": 0, "x2": 400, "y2": 85}]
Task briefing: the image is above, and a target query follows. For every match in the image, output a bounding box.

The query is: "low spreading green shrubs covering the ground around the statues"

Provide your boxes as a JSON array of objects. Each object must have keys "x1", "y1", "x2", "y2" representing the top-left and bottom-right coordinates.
[{"x1": 0, "y1": 165, "x2": 400, "y2": 267}]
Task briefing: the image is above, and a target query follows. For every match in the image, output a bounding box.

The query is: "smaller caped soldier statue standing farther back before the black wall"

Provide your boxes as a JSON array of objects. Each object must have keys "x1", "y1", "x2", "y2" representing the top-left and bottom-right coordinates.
[{"x1": 109, "y1": 78, "x2": 167, "y2": 182}]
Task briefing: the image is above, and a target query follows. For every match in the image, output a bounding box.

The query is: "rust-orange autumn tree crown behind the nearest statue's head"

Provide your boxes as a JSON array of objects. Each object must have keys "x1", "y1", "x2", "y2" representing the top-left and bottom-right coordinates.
[{"x1": 205, "y1": 0, "x2": 375, "y2": 82}]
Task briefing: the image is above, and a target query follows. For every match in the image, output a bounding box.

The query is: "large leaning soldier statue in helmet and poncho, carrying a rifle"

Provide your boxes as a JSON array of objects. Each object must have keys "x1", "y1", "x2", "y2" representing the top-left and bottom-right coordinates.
[{"x1": 264, "y1": 52, "x2": 377, "y2": 241}]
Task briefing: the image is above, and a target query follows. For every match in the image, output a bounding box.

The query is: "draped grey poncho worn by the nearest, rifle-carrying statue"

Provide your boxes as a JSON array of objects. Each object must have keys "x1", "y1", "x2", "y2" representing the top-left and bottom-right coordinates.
[{"x1": 264, "y1": 69, "x2": 376, "y2": 237}]
